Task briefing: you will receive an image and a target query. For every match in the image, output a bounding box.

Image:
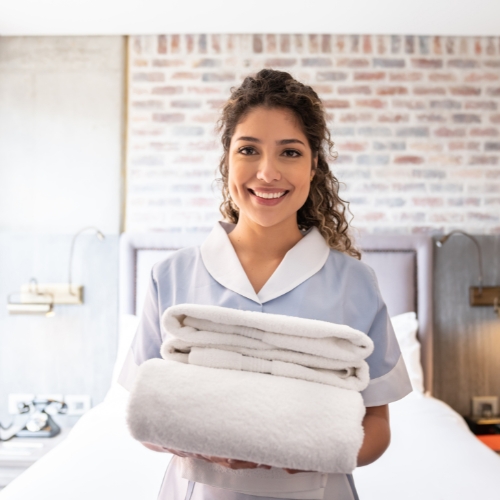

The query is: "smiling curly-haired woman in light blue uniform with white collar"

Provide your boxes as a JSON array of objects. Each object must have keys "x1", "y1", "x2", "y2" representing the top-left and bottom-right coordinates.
[{"x1": 121, "y1": 70, "x2": 411, "y2": 500}]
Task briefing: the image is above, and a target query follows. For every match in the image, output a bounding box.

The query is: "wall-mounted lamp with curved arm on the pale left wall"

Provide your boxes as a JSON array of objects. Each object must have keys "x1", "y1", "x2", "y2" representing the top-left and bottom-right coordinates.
[{"x1": 7, "y1": 226, "x2": 105, "y2": 316}]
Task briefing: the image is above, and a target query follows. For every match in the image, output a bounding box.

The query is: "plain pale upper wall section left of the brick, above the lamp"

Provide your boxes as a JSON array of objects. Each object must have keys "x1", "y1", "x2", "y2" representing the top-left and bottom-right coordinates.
[{"x1": 0, "y1": 37, "x2": 124, "y2": 234}]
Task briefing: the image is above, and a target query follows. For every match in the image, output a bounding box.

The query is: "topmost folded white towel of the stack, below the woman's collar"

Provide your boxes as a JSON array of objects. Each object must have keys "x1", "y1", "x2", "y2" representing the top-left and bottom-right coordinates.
[{"x1": 162, "y1": 304, "x2": 373, "y2": 362}]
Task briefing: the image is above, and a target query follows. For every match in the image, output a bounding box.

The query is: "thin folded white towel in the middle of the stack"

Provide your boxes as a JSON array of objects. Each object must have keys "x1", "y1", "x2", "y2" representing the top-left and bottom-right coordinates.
[{"x1": 162, "y1": 339, "x2": 369, "y2": 391}]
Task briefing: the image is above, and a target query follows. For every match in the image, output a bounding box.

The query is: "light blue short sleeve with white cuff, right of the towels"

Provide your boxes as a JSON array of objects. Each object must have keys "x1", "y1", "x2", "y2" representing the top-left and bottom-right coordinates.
[{"x1": 361, "y1": 269, "x2": 412, "y2": 406}]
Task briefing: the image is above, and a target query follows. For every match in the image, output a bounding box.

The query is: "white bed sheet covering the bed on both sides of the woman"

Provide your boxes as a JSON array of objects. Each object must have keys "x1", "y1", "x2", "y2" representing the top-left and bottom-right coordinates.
[{"x1": 0, "y1": 386, "x2": 500, "y2": 500}]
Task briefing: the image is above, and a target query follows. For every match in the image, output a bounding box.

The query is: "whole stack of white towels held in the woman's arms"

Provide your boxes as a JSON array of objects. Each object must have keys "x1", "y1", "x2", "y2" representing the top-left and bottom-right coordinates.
[{"x1": 128, "y1": 304, "x2": 373, "y2": 473}]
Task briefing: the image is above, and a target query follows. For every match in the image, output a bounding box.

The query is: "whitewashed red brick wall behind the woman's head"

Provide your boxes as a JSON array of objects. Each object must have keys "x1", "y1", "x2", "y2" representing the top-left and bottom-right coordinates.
[{"x1": 126, "y1": 35, "x2": 500, "y2": 234}]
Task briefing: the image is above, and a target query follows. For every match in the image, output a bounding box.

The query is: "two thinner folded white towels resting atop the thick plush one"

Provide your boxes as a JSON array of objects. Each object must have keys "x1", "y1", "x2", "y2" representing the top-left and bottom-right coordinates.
[{"x1": 161, "y1": 304, "x2": 373, "y2": 391}]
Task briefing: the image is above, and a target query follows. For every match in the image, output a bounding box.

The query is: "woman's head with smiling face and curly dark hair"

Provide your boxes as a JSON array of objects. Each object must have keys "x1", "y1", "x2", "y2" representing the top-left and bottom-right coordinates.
[{"x1": 219, "y1": 69, "x2": 359, "y2": 258}]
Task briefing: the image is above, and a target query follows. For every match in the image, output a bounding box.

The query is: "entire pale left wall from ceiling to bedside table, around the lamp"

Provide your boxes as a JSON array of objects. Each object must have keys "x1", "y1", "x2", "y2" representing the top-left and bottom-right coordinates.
[{"x1": 0, "y1": 37, "x2": 125, "y2": 424}]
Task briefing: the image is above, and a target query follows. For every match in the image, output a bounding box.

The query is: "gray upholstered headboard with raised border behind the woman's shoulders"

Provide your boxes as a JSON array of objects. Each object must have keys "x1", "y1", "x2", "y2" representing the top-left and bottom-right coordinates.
[{"x1": 119, "y1": 232, "x2": 433, "y2": 392}]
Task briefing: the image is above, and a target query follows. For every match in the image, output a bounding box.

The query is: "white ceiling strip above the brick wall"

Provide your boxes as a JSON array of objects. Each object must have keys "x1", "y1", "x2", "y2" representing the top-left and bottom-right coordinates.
[{"x1": 0, "y1": 0, "x2": 500, "y2": 36}]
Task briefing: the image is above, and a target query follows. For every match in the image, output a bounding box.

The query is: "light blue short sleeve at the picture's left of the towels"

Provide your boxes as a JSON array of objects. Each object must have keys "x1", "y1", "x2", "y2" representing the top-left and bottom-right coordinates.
[{"x1": 118, "y1": 270, "x2": 162, "y2": 391}]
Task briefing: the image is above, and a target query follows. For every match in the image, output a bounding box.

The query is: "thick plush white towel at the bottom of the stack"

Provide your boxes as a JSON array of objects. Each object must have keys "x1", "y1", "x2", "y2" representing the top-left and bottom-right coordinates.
[{"x1": 128, "y1": 359, "x2": 365, "y2": 473}]
